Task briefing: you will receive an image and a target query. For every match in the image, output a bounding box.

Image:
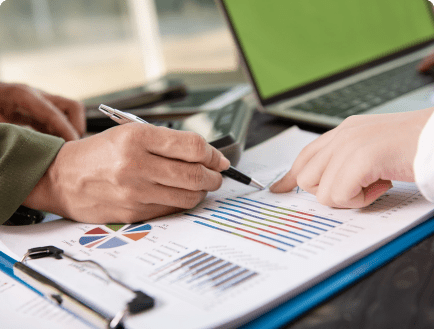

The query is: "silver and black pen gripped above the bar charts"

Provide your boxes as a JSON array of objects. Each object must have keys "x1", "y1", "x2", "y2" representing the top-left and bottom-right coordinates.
[{"x1": 98, "y1": 104, "x2": 265, "y2": 190}]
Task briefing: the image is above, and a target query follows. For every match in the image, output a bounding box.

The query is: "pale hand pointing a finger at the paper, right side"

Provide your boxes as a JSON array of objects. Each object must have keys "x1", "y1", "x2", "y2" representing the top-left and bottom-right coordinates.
[{"x1": 270, "y1": 108, "x2": 434, "y2": 208}]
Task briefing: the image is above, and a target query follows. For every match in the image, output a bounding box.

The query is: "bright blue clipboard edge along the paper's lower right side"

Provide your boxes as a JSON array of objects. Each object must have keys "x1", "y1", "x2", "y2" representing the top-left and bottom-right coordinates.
[{"x1": 239, "y1": 217, "x2": 434, "y2": 329}]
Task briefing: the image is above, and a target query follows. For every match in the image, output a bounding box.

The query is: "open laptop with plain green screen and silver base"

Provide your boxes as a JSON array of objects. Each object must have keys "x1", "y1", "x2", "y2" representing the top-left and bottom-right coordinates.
[{"x1": 218, "y1": 0, "x2": 434, "y2": 128}]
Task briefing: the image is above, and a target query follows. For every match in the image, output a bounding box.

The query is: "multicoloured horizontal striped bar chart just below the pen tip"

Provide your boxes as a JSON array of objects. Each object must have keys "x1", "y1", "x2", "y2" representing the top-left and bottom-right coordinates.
[{"x1": 184, "y1": 197, "x2": 343, "y2": 252}]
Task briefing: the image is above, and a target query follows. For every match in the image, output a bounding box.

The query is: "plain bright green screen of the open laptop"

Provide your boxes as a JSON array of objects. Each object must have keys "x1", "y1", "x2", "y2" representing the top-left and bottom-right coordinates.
[{"x1": 224, "y1": 0, "x2": 434, "y2": 99}]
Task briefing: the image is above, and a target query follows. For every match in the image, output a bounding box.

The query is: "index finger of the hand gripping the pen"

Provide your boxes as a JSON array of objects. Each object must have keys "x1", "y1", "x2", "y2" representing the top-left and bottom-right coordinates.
[{"x1": 139, "y1": 124, "x2": 230, "y2": 171}]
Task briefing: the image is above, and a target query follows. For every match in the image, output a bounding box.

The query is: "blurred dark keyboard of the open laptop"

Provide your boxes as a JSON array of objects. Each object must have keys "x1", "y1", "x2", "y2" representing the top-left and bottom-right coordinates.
[{"x1": 291, "y1": 61, "x2": 433, "y2": 118}]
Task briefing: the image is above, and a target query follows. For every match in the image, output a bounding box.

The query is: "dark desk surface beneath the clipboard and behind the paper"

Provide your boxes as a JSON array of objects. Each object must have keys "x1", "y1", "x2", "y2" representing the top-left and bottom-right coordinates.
[{"x1": 246, "y1": 112, "x2": 434, "y2": 329}]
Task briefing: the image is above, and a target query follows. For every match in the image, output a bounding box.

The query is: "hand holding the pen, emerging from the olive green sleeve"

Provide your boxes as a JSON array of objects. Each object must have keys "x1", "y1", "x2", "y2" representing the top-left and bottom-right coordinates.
[{"x1": 24, "y1": 123, "x2": 230, "y2": 223}]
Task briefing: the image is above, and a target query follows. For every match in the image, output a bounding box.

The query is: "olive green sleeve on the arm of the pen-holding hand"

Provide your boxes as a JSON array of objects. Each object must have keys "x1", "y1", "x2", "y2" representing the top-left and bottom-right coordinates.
[{"x1": 0, "y1": 123, "x2": 65, "y2": 224}]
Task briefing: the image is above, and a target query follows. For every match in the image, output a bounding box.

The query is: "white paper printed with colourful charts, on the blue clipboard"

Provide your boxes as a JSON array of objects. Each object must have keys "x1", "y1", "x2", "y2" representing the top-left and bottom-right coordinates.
[{"x1": 0, "y1": 128, "x2": 433, "y2": 329}]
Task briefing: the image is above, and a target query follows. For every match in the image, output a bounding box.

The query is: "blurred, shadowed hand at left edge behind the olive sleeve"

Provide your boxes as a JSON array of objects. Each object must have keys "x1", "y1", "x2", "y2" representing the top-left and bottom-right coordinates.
[{"x1": 0, "y1": 82, "x2": 86, "y2": 141}]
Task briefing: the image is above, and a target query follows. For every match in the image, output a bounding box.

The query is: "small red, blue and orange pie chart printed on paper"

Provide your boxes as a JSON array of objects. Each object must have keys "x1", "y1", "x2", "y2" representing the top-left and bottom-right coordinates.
[{"x1": 78, "y1": 223, "x2": 152, "y2": 249}]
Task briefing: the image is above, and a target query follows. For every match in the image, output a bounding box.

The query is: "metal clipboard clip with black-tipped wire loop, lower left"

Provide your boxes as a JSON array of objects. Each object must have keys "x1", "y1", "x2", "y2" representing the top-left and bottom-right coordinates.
[{"x1": 13, "y1": 246, "x2": 154, "y2": 329}]
